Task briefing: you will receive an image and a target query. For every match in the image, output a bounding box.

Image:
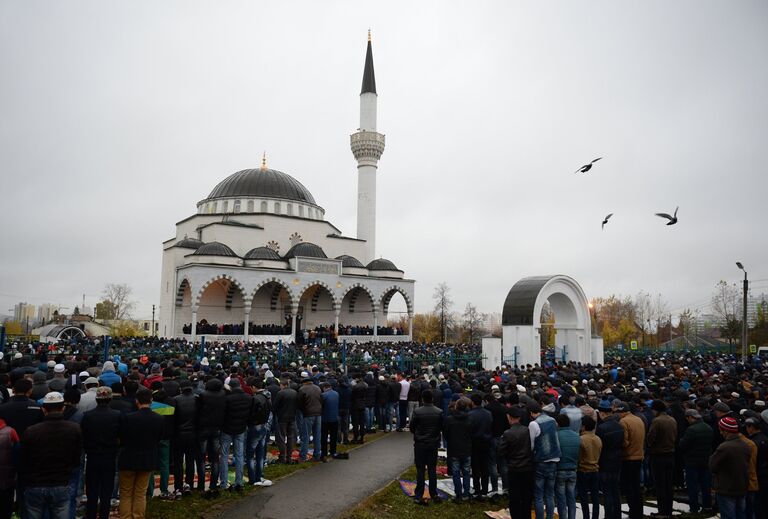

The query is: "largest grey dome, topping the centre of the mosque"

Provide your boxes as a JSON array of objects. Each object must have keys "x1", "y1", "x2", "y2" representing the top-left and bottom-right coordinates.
[{"x1": 208, "y1": 169, "x2": 317, "y2": 205}]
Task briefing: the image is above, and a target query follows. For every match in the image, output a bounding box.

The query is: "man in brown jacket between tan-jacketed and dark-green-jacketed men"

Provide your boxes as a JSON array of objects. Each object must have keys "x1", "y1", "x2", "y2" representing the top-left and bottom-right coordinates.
[{"x1": 646, "y1": 399, "x2": 677, "y2": 519}]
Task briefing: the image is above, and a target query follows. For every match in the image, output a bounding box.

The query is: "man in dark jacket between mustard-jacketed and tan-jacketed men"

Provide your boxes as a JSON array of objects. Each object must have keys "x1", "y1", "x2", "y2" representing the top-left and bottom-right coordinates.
[{"x1": 597, "y1": 403, "x2": 624, "y2": 519}]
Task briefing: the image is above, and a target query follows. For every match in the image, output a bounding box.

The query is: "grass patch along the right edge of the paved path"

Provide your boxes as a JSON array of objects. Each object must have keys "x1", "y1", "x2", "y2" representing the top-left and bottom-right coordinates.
[{"x1": 341, "y1": 467, "x2": 507, "y2": 519}]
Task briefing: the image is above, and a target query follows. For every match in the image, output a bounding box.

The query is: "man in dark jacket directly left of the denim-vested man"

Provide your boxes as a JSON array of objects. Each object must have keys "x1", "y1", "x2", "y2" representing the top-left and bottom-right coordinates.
[{"x1": 498, "y1": 406, "x2": 533, "y2": 519}]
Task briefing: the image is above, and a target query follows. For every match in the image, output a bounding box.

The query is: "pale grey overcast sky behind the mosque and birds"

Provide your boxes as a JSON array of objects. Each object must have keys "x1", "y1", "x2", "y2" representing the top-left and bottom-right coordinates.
[{"x1": 0, "y1": 0, "x2": 768, "y2": 317}]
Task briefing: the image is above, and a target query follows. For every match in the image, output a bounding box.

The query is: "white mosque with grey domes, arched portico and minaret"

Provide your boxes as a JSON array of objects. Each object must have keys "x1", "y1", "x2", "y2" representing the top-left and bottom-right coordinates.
[{"x1": 158, "y1": 34, "x2": 414, "y2": 342}]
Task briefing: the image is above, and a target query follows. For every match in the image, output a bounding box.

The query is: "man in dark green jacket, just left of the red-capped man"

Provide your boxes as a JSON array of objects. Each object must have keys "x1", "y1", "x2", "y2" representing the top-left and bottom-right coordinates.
[{"x1": 678, "y1": 409, "x2": 719, "y2": 514}]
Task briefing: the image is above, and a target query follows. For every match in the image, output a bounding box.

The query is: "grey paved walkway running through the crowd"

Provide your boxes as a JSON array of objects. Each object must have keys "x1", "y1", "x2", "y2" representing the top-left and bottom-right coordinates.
[{"x1": 222, "y1": 432, "x2": 413, "y2": 519}]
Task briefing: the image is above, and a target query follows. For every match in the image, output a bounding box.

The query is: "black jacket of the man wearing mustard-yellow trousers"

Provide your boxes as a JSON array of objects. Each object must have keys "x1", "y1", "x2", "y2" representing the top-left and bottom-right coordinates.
[{"x1": 117, "y1": 408, "x2": 165, "y2": 472}]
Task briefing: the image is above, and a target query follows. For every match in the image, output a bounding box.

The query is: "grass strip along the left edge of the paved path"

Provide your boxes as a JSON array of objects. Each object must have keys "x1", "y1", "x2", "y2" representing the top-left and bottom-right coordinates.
[{"x1": 147, "y1": 432, "x2": 384, "y2": 519}]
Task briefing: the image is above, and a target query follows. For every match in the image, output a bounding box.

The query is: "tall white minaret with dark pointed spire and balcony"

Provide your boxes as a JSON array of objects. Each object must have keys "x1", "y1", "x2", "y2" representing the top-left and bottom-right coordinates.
[{"x1": 350, "y1": 30, "x2": 384, "y2": 264}]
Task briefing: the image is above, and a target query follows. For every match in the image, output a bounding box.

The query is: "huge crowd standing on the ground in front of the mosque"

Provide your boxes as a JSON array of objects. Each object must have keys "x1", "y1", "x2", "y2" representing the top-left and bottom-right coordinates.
[{"x1": 0, "y1": 341, "x2": 768, "y2": 519}]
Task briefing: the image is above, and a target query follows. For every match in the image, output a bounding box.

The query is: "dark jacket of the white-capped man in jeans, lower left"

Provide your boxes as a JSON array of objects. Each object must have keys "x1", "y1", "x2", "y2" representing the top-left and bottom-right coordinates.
[{"x1": 20, "y1": 414, "x2": 83, "y2": 487}]
